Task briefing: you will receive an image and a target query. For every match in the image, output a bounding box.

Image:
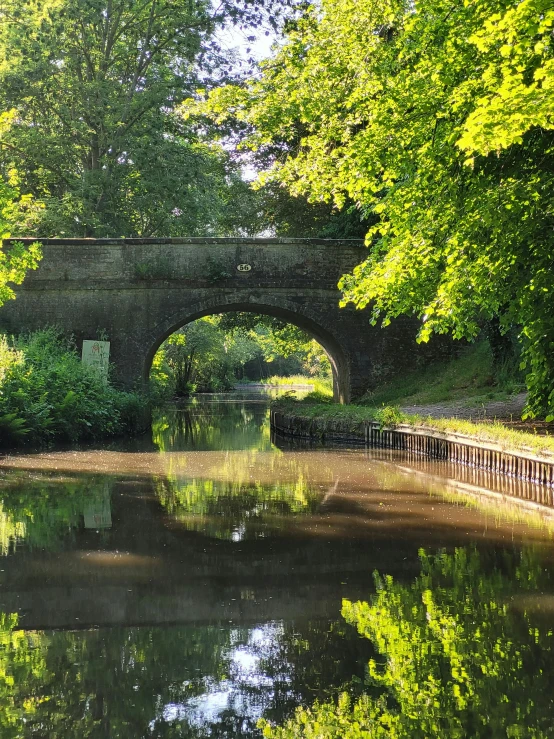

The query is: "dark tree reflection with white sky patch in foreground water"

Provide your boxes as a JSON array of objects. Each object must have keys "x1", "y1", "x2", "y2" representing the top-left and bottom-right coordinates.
[{"x1": 0, "y1": 614, "x2": 369, "y2": 739}]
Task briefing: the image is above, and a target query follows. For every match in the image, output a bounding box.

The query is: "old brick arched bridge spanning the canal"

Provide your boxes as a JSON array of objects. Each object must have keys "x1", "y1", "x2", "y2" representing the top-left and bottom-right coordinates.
[{"x1": 0, "y1": 238, "x2": 421, "y2": 403}]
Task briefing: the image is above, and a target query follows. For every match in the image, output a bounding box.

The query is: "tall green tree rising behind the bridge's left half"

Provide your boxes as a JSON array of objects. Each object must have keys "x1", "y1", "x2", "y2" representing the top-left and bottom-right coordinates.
[{"x1": 0, "y1": 0, "x2": 298, "y2": 236}]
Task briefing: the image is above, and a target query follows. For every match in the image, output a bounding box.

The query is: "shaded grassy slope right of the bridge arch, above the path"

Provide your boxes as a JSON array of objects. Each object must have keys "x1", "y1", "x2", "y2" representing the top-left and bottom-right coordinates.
[{"x1": 360, "y1": 341, "x2": 525, "y2": 407}]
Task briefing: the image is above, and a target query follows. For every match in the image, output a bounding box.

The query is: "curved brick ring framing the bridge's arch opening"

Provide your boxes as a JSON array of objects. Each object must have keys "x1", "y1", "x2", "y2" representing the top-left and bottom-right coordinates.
[{"x1": 143, "y1": 302, "x2": 349, "y2": 403}]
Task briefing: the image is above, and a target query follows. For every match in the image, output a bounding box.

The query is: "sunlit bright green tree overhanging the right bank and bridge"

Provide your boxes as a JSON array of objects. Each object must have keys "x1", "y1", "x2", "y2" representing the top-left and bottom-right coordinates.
[{"x1": 190, "y1": 0, "x2": 554, "y2": 418}]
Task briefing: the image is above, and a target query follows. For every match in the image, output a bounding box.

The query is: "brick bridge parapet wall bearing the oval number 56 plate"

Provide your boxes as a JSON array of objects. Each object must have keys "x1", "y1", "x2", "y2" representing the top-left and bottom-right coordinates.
[{"x1": 5, "y1": 238, "x2": 365, "y2": 289}]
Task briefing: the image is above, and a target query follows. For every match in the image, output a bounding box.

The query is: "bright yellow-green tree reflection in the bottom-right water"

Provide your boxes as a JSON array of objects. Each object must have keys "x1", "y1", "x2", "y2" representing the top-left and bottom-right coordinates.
[{"x1": 261, "y1": 548, "x2": 554, "y2": 739}]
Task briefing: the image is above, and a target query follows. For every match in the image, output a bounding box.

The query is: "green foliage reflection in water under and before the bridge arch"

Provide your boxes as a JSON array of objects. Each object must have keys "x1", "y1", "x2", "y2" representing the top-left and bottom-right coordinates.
[{"x1": 153, "y1": 401, "x2": 333, "y2": 541}]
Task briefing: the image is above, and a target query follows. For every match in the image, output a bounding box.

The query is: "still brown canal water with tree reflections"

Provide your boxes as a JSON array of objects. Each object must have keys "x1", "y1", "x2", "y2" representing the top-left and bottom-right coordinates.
[{"x1": 0, "y1": 395, "x2": 554, "y2": 739}]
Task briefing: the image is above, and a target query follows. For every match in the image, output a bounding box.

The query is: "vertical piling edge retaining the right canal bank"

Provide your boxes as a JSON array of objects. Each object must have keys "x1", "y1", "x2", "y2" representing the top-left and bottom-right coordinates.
[{"x1": 271, "y1": 408, "x2": 554, "y2": 487}]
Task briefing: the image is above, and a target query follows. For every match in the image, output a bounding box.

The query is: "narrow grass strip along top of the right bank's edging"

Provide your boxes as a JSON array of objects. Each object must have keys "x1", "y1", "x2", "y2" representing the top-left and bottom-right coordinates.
[{"x1": 273, "y1": 398, "x2": 554, "y2": 454}]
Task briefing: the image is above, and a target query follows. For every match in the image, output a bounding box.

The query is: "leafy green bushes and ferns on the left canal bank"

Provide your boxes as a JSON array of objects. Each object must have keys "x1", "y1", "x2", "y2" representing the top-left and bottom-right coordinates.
[{"x1": 0, "y1": 329, "x2": 150, "y2": 447}]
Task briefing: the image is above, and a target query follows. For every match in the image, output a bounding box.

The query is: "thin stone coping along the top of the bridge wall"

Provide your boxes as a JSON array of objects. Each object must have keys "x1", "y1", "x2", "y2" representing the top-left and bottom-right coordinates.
[{"x1": 3, "y1": 236, "x2": 364, "y2": 247}]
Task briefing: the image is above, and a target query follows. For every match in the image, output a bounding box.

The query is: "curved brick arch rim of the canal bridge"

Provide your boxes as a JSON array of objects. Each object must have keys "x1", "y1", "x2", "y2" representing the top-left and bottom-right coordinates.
[{"x1": 142, "y1": 297, "x2": 350, "y2": 403}]
